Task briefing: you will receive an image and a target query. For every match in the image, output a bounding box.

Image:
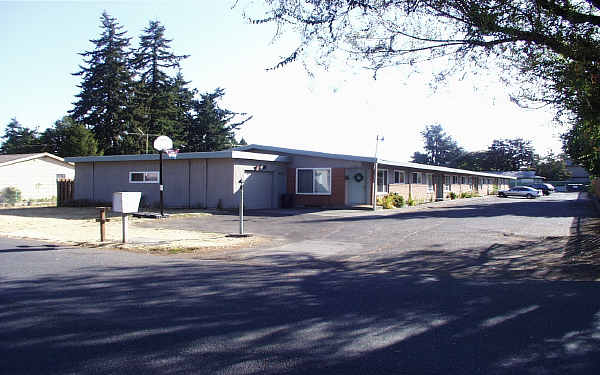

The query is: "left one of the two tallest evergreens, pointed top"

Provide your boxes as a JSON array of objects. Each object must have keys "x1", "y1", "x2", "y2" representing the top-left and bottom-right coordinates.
[{"x1": 70, "y1": 12, "x2": 132, "y2": 155}]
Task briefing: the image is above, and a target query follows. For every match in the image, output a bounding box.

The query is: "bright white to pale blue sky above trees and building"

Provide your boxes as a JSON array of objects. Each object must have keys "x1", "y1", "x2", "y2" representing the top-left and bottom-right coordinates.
[{"x1": 0, "y1": 0, "x2": 560, "y2": 161}]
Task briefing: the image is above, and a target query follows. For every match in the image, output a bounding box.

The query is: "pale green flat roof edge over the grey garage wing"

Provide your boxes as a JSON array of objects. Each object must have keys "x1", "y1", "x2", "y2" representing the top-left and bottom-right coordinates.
[{"x1": 65, "y1": 149, "x2": 290, "y2": 163}]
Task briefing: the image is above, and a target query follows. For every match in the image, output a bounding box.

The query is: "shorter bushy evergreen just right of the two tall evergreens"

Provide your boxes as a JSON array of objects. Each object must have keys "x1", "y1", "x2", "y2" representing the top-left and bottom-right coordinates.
[{"x1": 183, "y1": 88, "x2": 252, "y2": 152}]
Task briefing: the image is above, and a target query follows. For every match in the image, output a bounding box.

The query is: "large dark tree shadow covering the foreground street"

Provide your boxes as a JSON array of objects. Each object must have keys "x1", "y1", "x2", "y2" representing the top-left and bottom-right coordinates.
[{"x1": 0, "y1": 239, "x2": 600, "y2": 374}]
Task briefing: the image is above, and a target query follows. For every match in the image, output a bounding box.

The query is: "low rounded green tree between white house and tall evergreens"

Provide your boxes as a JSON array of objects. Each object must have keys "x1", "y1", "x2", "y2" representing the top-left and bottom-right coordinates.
[{"x1": 41, "y1": 116, "x2": 98, "y2": 157}]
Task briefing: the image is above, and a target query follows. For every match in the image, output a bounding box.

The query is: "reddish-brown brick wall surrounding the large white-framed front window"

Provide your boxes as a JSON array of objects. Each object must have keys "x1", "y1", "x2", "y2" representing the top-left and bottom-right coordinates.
[{"x1": 287, "y1": 168, "x2": 346, "y2": 207}]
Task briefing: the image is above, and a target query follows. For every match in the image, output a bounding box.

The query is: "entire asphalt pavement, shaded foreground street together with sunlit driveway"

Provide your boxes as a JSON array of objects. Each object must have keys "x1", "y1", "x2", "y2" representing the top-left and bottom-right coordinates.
[{"x1": 0, "y1": 194, "x2": 600, "y2": 375}]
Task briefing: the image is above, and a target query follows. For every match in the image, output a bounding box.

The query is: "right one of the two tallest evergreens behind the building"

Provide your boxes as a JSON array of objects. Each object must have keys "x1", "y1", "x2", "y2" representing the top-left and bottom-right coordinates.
[{"x1": 133, "y1": 21, "x2": 188, "y2": 144}]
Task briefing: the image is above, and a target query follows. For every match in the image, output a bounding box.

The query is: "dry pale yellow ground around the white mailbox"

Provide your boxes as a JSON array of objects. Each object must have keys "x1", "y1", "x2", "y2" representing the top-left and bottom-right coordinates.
[{"x1": 0, "y1": 207, "x2": 268, "y2": 254}]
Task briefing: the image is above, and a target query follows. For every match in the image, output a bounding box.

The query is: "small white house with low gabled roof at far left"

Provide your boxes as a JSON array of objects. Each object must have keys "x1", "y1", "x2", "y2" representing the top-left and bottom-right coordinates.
[{"x1": 0, "y1": 152, "x2": 75, "y2": 200}]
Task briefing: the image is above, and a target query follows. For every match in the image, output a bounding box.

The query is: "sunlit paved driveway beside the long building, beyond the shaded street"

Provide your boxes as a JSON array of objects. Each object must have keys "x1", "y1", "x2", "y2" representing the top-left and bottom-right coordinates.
[{"x1": 139, "y1": 193, "x2": 595, "y2": 273}]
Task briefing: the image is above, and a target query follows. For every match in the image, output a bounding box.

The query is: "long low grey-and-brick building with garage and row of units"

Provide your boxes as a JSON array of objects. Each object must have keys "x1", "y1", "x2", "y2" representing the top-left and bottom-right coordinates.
[{"x1": 66, "y1": 145, "x2": 514, "y2": 209}]
